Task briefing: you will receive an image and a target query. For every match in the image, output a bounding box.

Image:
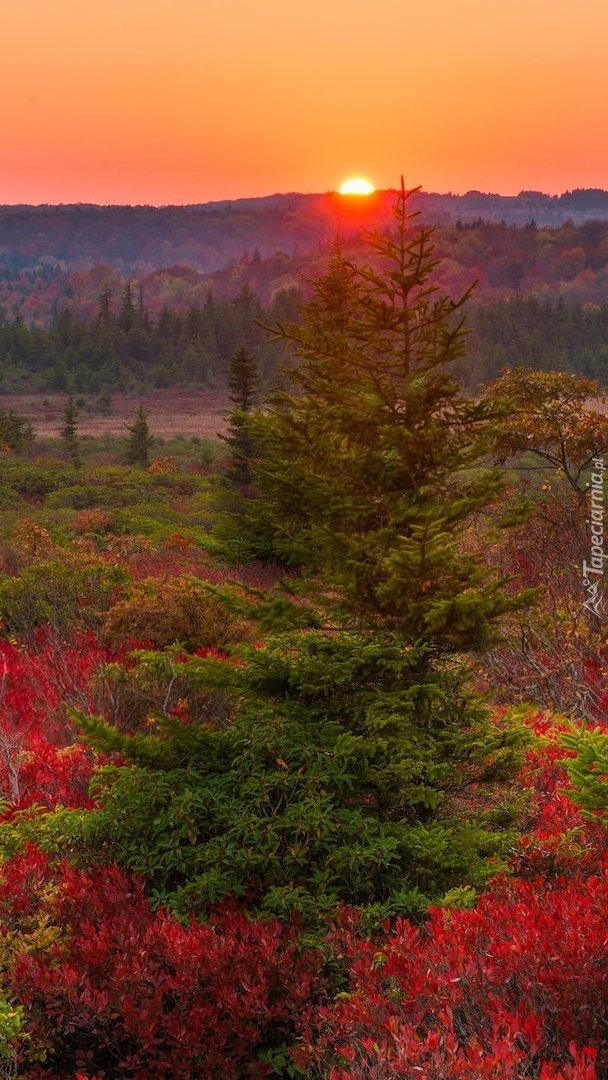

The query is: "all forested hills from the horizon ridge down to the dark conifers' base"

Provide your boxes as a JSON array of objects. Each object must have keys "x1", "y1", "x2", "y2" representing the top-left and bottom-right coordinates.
[{"x1": 0, "y1": 190, "x2": 608, "y2": 395}]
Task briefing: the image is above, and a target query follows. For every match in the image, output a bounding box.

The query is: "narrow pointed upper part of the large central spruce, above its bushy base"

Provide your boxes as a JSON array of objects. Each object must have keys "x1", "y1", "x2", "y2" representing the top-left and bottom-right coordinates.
[{"x1": 253, "y1": 189, "x2": 533, "y2": 652}]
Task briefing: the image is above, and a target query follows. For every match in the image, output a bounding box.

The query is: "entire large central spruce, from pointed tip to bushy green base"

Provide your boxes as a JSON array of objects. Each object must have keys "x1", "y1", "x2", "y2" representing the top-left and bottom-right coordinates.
[{"x1": 22, "y1": 190, "x2": 537, "y2": 928}]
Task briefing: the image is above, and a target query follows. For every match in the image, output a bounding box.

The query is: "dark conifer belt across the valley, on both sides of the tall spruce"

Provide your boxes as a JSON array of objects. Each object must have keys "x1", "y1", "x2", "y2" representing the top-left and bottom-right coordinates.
[{"x1": 0, "y1": 283, "x2": 608, "y2": 394}]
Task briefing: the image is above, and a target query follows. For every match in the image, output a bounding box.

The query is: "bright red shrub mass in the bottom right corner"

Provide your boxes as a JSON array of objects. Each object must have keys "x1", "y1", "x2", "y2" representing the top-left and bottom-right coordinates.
[{"x1": 299, "y1": 861, "x2": 608, "y2": 1080}]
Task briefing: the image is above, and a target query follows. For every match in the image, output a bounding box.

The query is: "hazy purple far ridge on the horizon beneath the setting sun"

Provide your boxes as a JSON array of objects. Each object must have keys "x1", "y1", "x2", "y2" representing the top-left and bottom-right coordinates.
[{"x1": 0, "y1": 185, "x2": 608, "y2": 274}]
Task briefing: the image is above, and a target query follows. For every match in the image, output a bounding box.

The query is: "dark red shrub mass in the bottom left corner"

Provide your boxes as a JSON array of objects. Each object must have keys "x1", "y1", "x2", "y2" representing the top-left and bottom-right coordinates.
[{"x1": 0, "y1": 851, "x2": 320, "y2": 1080}]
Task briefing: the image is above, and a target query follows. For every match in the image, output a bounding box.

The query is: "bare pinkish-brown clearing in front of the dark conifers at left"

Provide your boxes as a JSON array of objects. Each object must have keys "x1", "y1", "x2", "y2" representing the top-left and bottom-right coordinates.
[{"x1": 0, "y1": 390, "x2": 229, "y2": 438}]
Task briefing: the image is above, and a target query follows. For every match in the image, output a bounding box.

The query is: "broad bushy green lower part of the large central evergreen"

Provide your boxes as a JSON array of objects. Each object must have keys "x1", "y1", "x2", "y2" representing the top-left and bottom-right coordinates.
[{"x1": 52, "y1": 627, "x2": 523, "y2": 933}]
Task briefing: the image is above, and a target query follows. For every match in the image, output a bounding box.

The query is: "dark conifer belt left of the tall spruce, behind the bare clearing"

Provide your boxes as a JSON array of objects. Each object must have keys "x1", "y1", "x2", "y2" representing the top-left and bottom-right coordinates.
[{"x1": 0, "y1": 282, "x2": 297, "y2": 394}]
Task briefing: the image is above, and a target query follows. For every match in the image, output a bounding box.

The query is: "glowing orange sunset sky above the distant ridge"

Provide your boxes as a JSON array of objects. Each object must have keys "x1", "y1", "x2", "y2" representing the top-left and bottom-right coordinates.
[{"x1": 0, "y1": 0, "x2": 608, "y2": 205}]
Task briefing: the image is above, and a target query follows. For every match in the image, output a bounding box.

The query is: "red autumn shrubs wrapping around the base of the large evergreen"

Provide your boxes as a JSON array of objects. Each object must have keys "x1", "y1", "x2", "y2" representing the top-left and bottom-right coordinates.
[{"x1": 0, "y1": 535, "x2": 608, "y2": 1080}]
